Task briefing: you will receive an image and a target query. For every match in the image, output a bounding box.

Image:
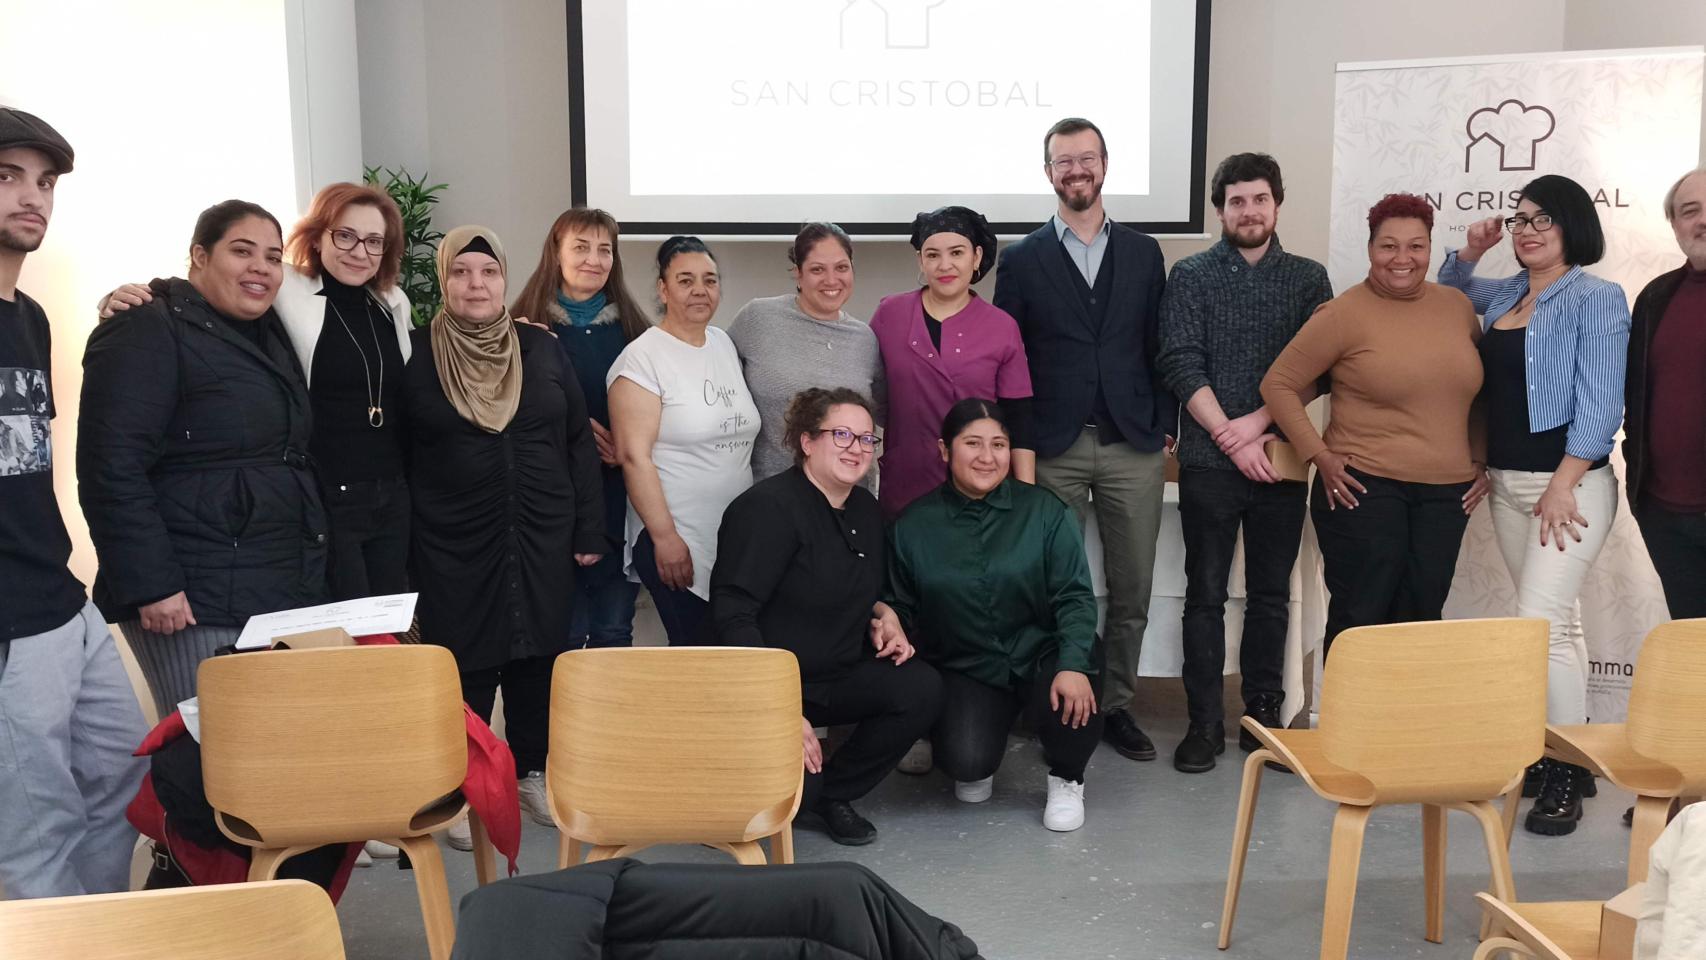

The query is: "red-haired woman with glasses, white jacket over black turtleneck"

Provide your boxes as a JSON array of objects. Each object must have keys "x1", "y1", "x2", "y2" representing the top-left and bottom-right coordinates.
[{"x1": 101, "y1": 182, "x2": 413, "y2": 600}]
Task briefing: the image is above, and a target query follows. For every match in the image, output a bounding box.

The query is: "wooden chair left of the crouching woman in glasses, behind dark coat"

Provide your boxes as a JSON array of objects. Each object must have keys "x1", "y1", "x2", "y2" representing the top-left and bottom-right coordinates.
[{"x1": 544, "y1": 646, "x2": 805, "y2": 866}]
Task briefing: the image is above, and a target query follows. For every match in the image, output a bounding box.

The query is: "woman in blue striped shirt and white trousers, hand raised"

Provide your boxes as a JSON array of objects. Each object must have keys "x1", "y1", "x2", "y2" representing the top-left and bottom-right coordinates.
[{"x1": 1440, "y1": 176, "x2": 1629, "y2": 836}]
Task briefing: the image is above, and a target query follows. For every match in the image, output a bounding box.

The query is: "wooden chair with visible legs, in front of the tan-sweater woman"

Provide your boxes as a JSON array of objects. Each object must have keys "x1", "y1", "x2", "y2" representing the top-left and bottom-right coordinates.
[{"x1": 1220, "y1": 619, "x2": 1546, "y2": 960}]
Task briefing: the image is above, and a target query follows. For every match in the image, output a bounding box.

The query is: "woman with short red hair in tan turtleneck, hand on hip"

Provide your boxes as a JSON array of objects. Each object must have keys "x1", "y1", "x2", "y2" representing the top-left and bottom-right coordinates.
[{"x1": 1262, "y1": 193, "x2": 1488, "y2": 646}]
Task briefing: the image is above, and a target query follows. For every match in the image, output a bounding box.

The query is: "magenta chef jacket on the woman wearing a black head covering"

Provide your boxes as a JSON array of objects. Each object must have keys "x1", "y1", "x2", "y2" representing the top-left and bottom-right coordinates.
[{"x1": 870, "y1": 290, "x2": 1030, "y2": 520}]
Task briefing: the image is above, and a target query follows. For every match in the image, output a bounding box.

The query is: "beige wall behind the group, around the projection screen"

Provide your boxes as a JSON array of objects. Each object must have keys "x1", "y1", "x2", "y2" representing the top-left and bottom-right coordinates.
[{"x1": 357, "y1": 0, "x2": 1637, "y2": 321}]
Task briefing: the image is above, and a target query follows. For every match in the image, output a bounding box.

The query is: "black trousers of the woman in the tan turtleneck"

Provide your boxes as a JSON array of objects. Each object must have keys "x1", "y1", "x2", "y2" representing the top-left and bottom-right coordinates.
[{"x1": 1310, "y1": 471, "x2": 1469, "y2": 651}]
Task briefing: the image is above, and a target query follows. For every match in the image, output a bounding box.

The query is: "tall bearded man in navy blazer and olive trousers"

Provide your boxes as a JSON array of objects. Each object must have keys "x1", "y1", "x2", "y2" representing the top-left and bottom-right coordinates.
[{"x1": 995, "y1": 118, "x2": 1179, "y2": 760}]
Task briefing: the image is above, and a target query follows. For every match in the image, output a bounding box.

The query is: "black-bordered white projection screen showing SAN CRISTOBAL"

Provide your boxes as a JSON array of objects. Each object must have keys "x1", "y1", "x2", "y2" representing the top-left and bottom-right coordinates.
[{"x1": 568, "y1": 0, "x2": 1206, "y2": 234}]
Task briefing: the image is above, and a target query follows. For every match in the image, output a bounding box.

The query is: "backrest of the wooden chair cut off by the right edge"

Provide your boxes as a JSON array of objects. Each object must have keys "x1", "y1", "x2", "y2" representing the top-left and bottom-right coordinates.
[{"x1": 1624, "y1": 621, "x2": 1706, "y2": 796}]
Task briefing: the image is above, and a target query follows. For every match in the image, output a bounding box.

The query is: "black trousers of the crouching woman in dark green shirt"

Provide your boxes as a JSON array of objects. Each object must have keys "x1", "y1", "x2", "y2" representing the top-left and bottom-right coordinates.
[{"x1": 930, "y1": 651, "x2": 1104, "y2": 783}]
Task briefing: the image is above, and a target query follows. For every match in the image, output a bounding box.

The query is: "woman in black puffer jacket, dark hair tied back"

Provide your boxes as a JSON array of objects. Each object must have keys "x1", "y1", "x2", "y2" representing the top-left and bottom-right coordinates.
[{"x1": 77, "y1": 200, "x2": 326, "y2": 716}]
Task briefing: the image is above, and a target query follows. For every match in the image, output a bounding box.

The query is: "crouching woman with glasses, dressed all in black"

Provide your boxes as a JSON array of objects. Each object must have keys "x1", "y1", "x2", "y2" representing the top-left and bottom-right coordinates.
[{"x1": 711, "y1": 387, "x2": 942, "y2": 846}]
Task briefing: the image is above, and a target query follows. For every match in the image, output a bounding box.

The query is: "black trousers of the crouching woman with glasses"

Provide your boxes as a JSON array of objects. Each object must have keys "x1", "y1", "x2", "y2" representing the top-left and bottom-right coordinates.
[{"x1": 800, "y1": 658, "x2": 942, "y2": 810}]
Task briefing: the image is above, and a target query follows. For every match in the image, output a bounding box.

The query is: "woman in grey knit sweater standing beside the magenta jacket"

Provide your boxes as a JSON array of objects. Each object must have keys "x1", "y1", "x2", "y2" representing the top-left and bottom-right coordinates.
[{"x1": 728, "y1": 223, "x2": 887, "y2": 488}]
